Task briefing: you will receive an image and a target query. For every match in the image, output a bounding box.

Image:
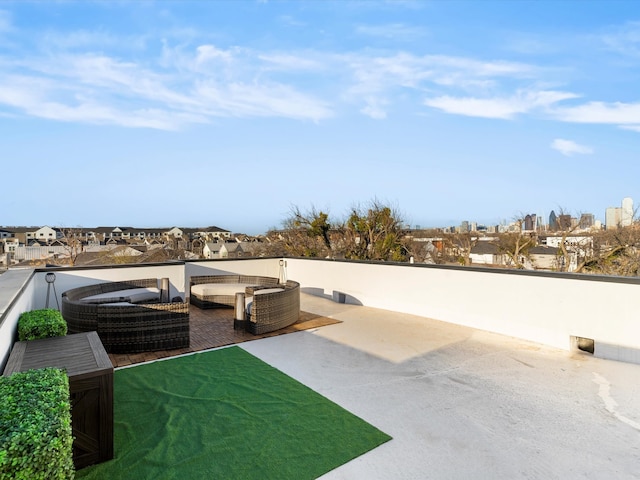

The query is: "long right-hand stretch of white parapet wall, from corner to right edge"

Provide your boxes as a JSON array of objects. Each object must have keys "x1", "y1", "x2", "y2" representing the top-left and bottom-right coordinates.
[{"x1": 288, "y1": 259, "x2": 640, "y2": 363}]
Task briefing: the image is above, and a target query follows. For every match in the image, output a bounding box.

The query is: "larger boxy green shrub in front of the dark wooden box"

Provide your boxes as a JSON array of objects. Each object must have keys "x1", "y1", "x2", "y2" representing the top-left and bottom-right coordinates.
[{"x1": 0, "y1": 368, "x2": 75, "y2": 480}]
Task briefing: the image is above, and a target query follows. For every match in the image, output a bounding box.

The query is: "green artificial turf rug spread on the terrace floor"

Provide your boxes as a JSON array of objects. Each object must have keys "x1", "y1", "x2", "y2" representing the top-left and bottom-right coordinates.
[{"x1": 76, "y1": 347, "x2": 391, "y2": 480}]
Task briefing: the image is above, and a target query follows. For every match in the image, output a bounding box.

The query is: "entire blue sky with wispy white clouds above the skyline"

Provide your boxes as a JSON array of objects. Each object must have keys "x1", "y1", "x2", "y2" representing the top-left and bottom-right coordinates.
[{"x1": 0, "y1": 0, "x2": 640, "y2": 234}]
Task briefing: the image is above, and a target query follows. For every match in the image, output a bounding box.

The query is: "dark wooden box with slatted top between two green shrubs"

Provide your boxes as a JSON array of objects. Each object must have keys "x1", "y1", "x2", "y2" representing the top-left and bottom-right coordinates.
[{"x1": 3, "y1": 332, "x2": 113, "y2": 469}]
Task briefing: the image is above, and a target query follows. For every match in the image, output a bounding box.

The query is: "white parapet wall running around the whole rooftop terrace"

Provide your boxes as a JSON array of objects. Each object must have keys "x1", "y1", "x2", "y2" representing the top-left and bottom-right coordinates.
[{"x1": 0, "y1": 258, "x2": 640, "y2": 366}]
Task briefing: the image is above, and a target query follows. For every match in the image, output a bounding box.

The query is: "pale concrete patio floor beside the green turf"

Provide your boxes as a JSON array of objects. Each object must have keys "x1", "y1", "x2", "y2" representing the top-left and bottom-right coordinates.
[{"x1": 240, "y1": 294, "x2": 640, "y2": 480}]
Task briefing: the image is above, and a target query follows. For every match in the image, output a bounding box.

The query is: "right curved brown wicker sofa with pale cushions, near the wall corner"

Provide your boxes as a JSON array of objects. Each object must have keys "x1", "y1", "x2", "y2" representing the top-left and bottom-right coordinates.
[{"x1": 189, "y1": 275, "x2": 300, "y2": 335}]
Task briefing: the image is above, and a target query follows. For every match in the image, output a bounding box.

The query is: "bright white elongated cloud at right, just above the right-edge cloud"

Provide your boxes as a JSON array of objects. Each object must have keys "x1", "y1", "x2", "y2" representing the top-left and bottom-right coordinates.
[{"x1": 424, "y1": 91, "x2": 576, "y2": 120}]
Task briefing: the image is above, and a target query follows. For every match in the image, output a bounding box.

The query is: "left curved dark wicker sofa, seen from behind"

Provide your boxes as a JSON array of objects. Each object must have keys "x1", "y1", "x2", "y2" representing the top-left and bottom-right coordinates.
[{"x1": 61, "y1": 278, "x2": 189, "y2": 353}]
